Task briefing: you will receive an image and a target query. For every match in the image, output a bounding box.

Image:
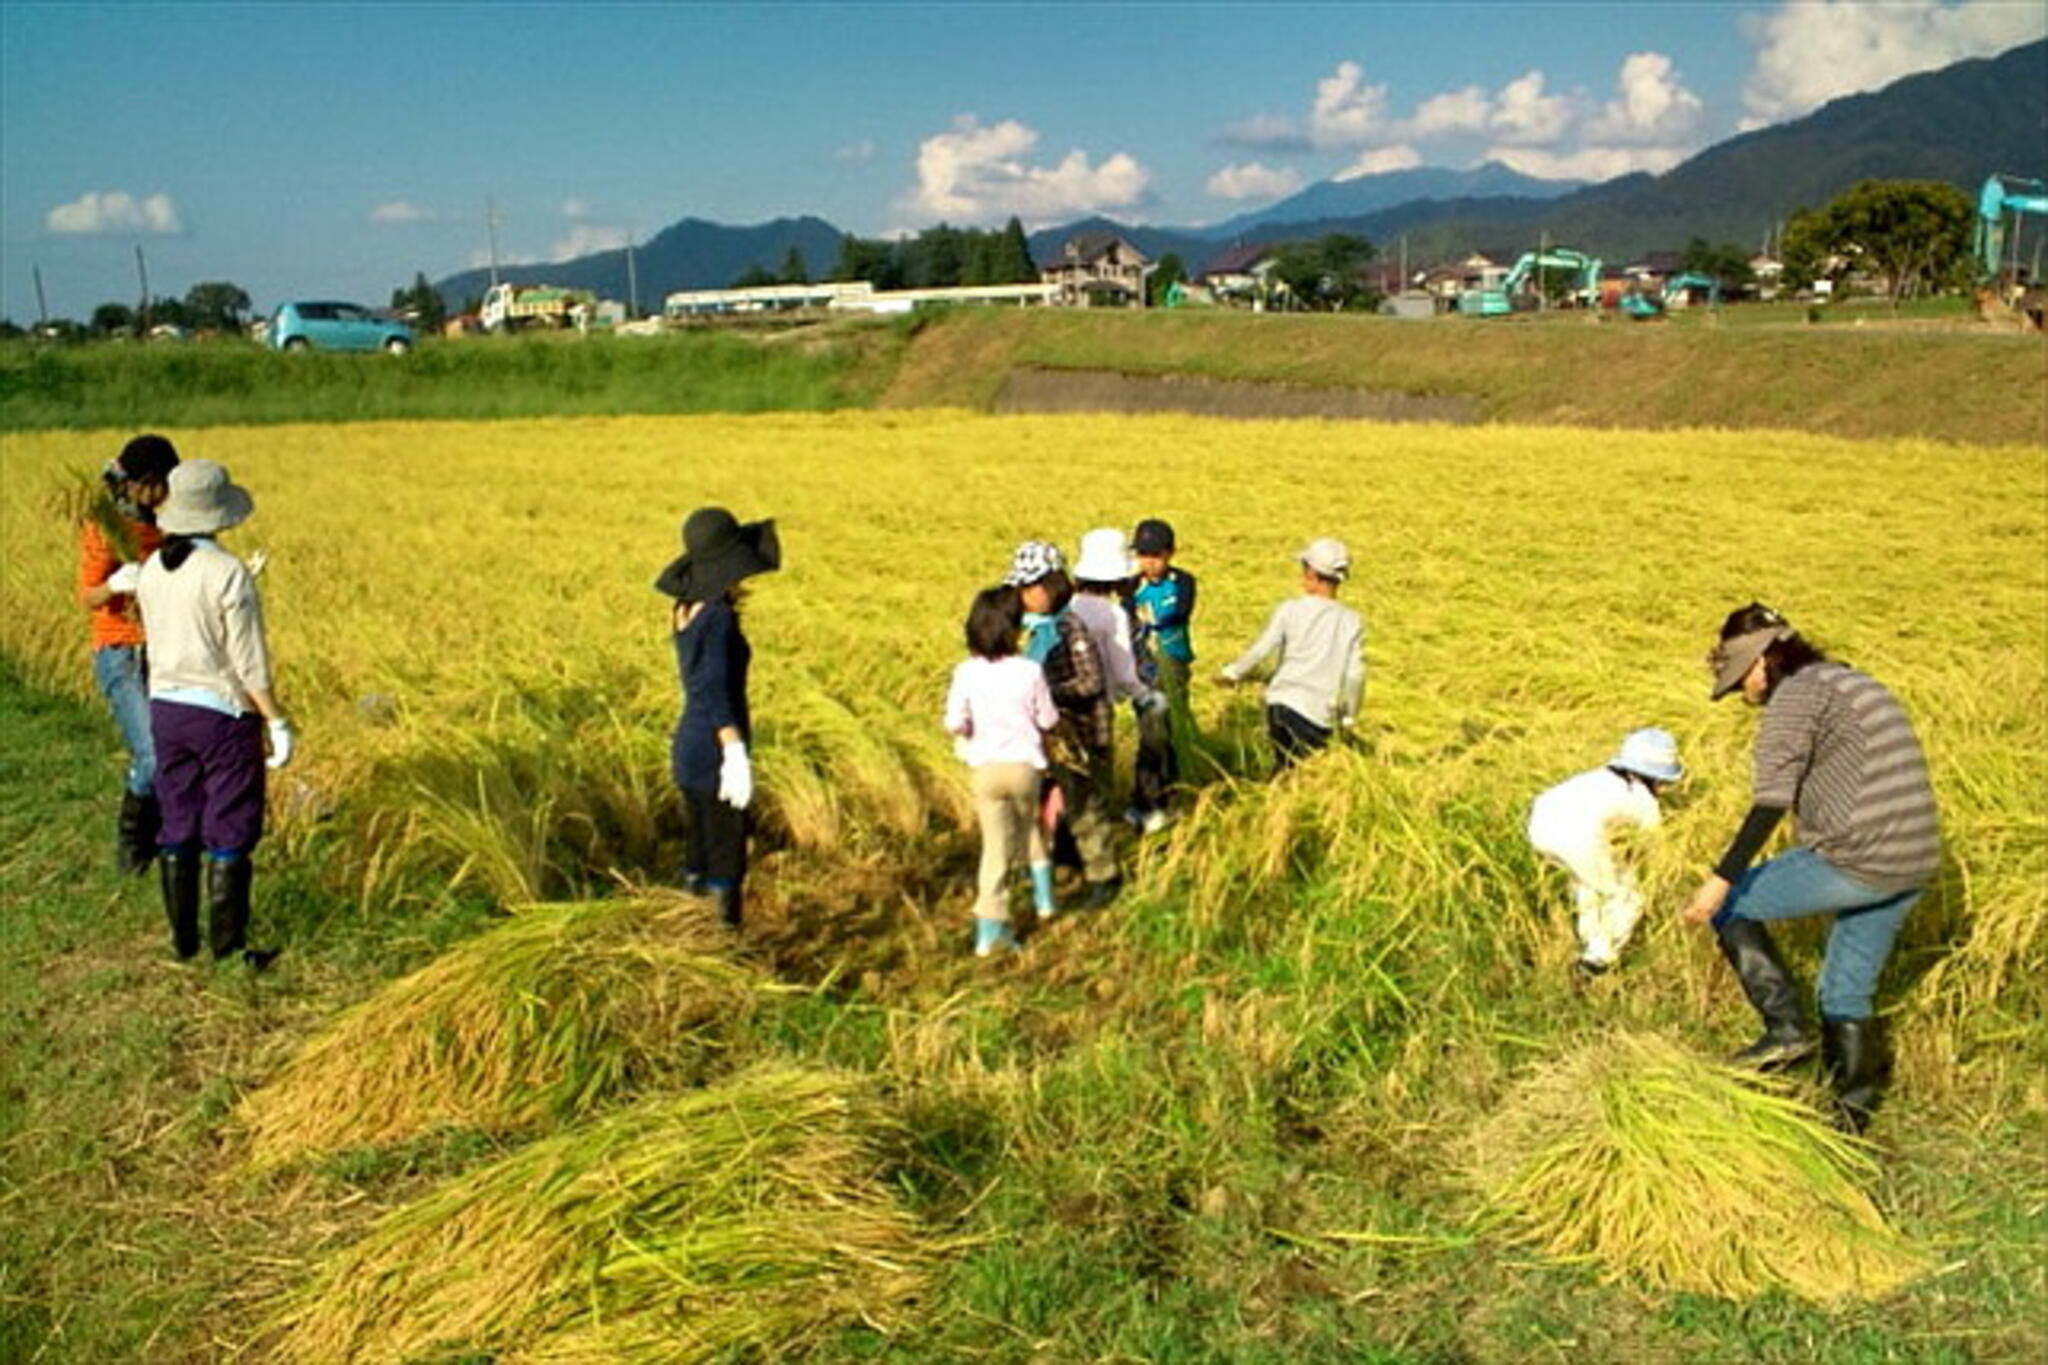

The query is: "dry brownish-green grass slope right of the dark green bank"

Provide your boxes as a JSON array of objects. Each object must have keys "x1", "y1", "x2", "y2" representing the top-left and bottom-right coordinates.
[{"x1": 883, "y1": 301, "x2": 2048, "y2": 444}]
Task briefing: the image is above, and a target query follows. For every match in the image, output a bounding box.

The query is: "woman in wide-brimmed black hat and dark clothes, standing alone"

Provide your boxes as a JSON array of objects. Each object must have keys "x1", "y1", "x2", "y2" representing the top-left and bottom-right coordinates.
[{"x1": 655, "y1": 508, "x2": 782, "y2": 929}]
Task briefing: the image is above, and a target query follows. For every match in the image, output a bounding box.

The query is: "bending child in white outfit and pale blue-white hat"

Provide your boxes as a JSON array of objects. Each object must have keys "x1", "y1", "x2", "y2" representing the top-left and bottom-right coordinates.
[{"x1": 1530, "y1": 731, "x2": 1686, "y2": 974}]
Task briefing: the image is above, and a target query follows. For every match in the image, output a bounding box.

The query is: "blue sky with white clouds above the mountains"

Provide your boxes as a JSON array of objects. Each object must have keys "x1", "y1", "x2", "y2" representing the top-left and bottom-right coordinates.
[{"x1": 0, "y1": 0, "x2": 2048, "y2": 321}]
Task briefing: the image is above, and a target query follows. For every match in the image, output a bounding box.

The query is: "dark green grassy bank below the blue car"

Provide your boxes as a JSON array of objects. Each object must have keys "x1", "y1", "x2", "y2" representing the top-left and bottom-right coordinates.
[{"x1": 0, "y1": 327, "x2": 897, "y2": 430}]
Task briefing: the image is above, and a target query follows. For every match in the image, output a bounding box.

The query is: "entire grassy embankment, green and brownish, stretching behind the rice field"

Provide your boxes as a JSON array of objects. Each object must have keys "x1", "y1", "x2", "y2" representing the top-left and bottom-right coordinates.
[{"x1": 0, "y1": 305, "x2": 2048, "y2": 444}]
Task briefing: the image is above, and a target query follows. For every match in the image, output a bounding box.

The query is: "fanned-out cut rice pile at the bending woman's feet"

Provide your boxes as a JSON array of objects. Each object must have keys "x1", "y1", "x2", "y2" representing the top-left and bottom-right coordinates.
[{"x1": 1473, "y1": 1033, "x2": 1929, "y2": 1304}]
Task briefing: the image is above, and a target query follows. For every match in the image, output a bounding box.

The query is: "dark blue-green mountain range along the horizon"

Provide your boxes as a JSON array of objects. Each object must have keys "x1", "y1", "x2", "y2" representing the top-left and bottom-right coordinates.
[{"x1": 436, "y1": 41, "x2": 2048, "y2": 307}]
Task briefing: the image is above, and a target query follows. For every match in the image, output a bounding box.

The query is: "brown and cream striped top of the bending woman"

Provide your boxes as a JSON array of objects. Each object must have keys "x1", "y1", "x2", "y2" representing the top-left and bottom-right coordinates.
[{"x1": 1755, "y1": 663, "x2": 1942, "y2": 892}]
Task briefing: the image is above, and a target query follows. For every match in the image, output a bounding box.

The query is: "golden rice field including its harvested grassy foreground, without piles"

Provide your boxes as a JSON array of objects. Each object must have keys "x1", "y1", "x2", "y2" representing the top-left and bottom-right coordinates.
[{"x1": 0, "y1": 413, "x2": 2048, "y2": 1361}]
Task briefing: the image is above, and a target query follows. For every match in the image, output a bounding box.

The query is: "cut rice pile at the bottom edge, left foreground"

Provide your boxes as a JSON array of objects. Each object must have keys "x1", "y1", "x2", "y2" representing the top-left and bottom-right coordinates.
[{"x1": 274, "y1": 1066, "x2": 936, "y2": 1363}]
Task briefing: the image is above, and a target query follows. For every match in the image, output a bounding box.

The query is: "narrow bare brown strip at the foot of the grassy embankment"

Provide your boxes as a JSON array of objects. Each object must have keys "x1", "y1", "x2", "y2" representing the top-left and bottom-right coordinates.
[{"x1": 993, "y1": 368, "x2": 1481, "y2": 424}]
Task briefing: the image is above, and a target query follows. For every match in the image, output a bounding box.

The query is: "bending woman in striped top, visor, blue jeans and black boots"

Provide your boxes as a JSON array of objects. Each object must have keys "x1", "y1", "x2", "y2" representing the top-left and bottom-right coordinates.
[{"x1": 1683, "y1": 602, "x2": 1942, "y2": 1132}]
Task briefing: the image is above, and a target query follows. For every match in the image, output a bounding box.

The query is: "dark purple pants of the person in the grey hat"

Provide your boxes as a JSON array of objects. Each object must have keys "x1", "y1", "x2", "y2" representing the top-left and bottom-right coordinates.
[{"x1": 150, "y1": 702, "x2": 264, "y2": 853}]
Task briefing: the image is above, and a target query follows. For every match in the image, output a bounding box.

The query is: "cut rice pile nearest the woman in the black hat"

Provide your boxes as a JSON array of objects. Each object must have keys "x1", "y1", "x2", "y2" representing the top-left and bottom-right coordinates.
[{"x1": 238, "y1": 894, "x2": 770, "y2": 1169}]
